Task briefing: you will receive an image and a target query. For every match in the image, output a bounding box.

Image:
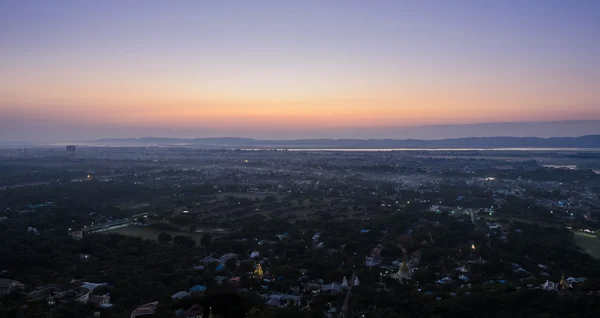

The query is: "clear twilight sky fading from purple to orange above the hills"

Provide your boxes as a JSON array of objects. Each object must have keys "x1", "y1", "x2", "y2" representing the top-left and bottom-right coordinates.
[{"x1": 0, "y1": 0, "x2": 600, "y2": 141}]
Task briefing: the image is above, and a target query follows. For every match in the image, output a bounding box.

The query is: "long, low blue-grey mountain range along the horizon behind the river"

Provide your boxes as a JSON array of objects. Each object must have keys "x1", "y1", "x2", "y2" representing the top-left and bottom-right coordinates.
[{"x1": 86, "y1": 135, "x2": 600, "y2": 149}]
